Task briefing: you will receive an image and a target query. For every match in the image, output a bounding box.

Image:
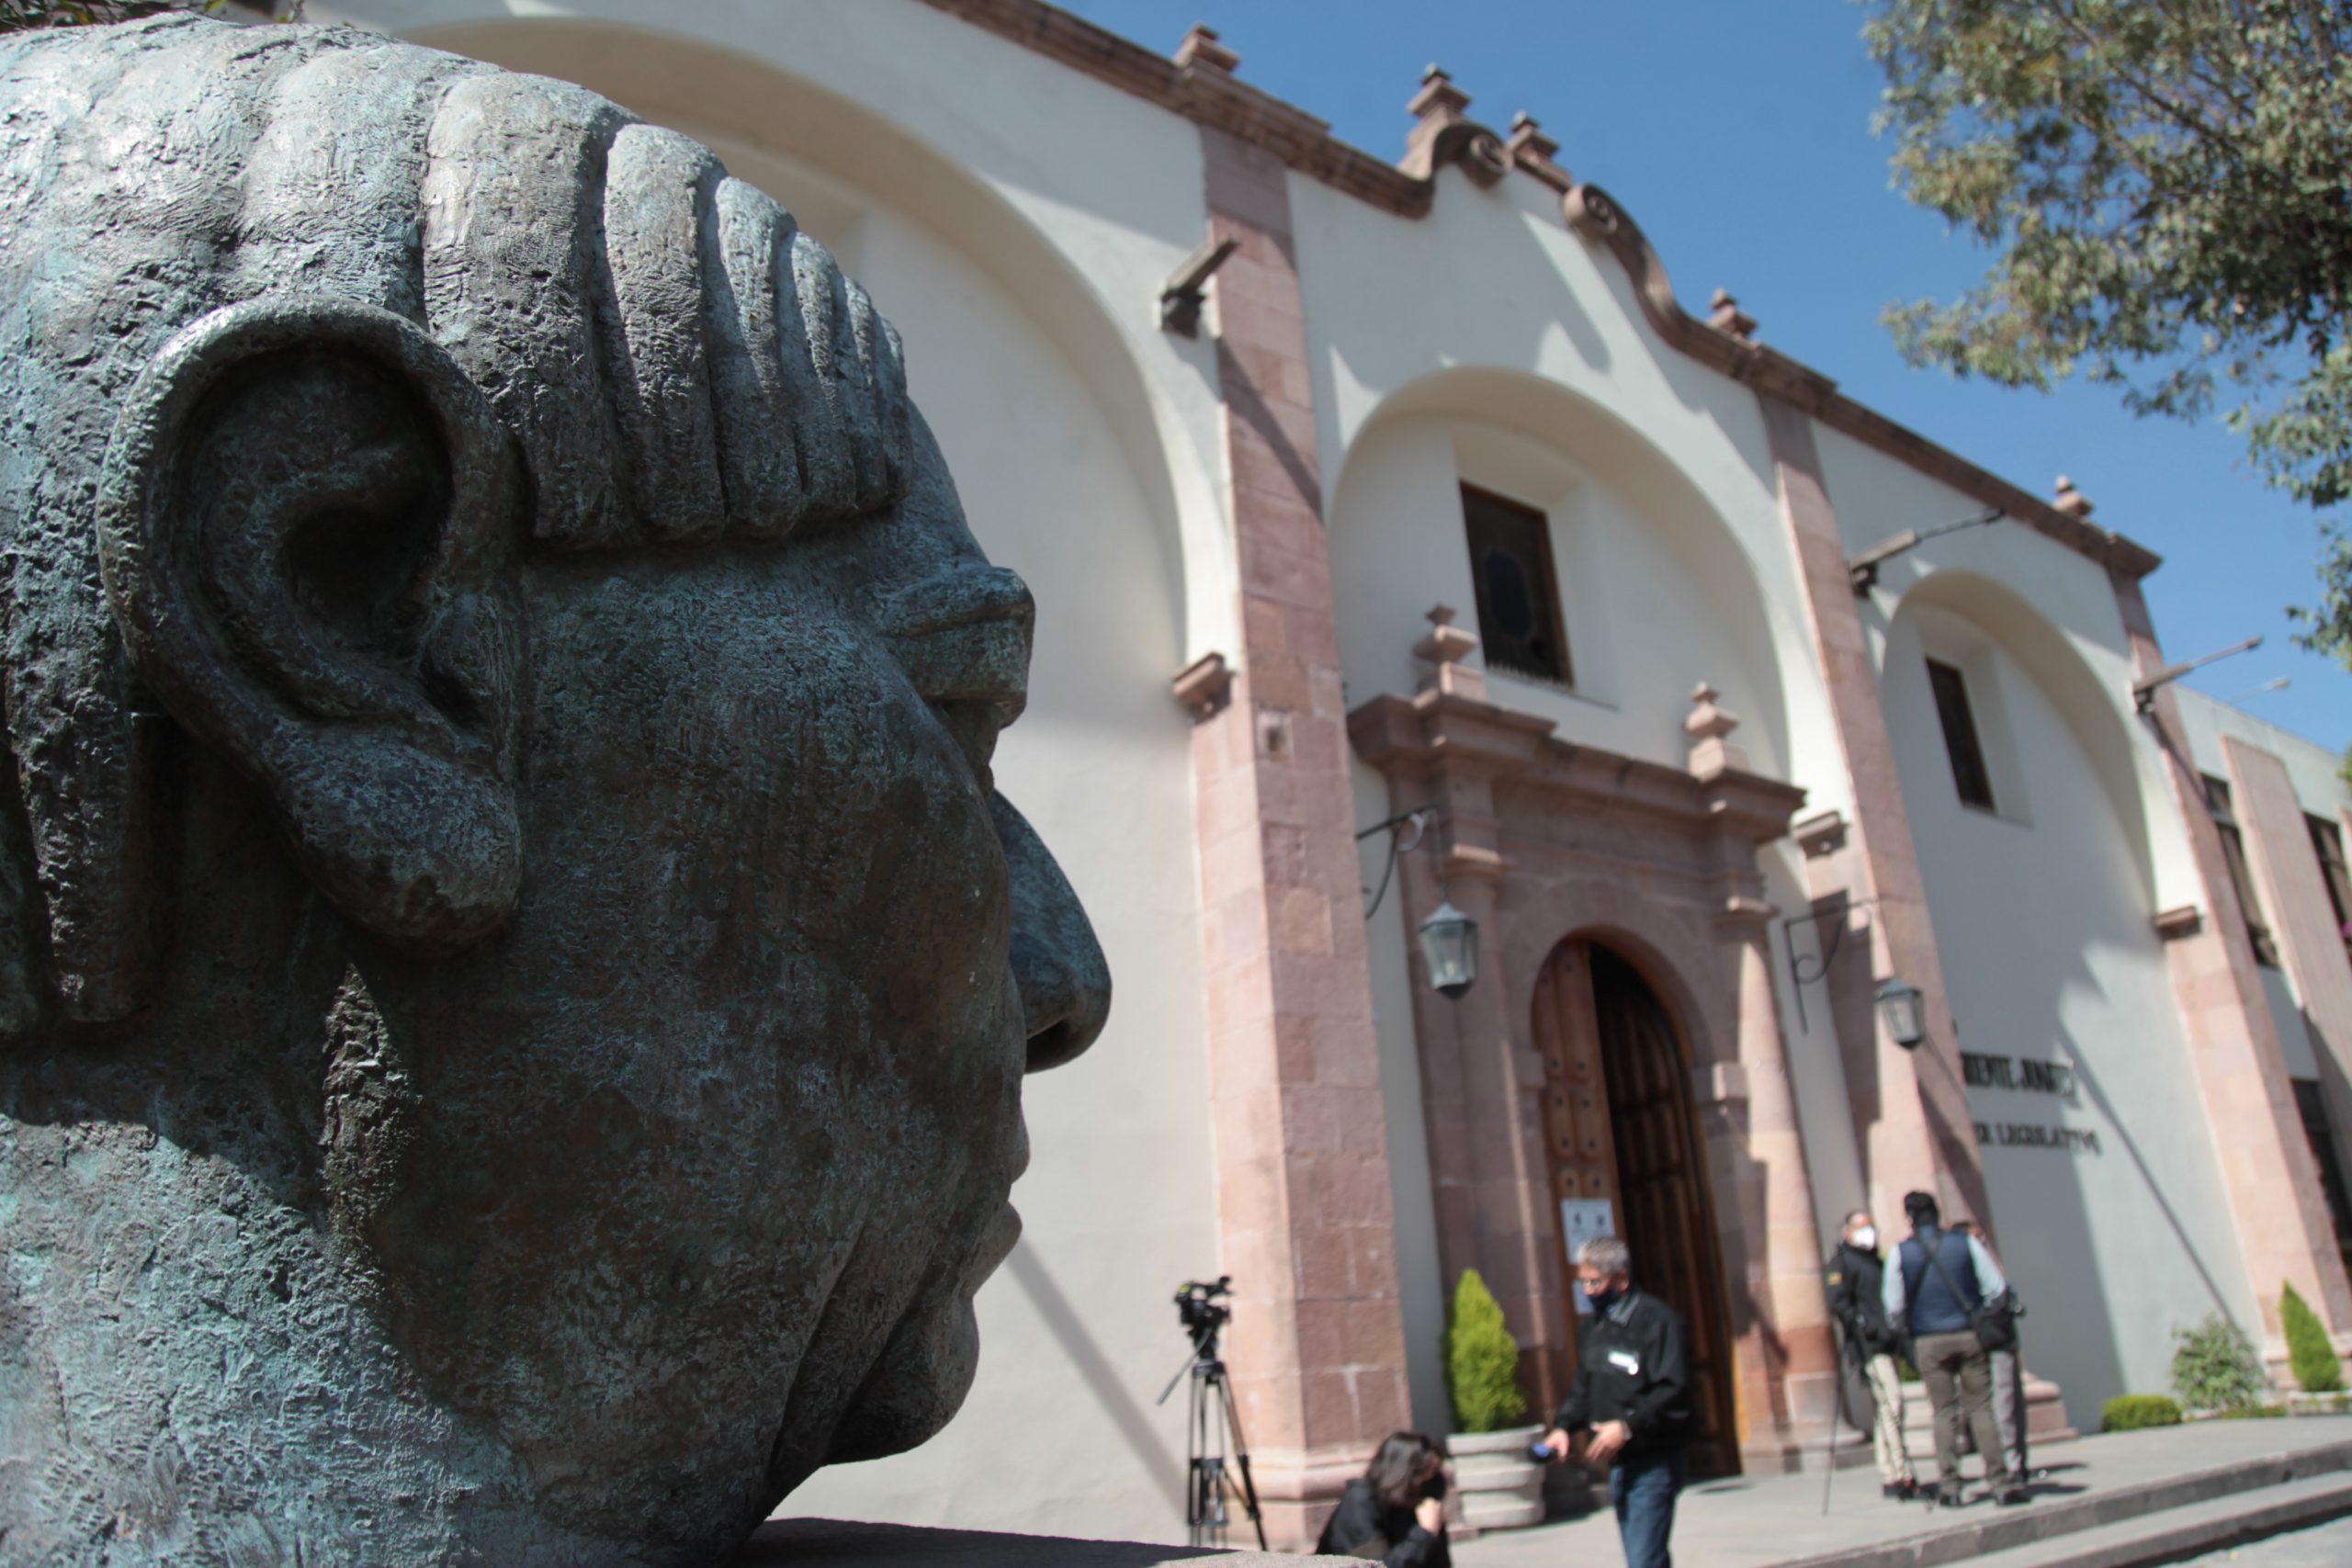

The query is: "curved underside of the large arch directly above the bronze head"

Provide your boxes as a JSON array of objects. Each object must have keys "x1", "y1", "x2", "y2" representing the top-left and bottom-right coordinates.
[{"x1": 407, "y1": 7, "x2": 1235, "y2": 668}]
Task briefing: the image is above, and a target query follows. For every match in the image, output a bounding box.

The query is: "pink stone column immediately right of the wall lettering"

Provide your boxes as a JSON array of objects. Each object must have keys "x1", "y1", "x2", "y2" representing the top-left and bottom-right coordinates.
[{"x1": 2114, "y1": 573, "x2": 2352, "y2": 1342}]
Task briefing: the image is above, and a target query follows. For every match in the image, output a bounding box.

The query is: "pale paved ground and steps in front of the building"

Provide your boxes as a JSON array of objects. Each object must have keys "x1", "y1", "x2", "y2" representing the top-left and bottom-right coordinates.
[{"x1": 1453, "y1": 1416, "x2": 2352, "y2": 1568}]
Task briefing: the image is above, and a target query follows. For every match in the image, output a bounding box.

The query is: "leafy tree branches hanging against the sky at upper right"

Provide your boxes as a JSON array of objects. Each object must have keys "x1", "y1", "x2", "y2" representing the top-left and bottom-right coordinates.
[{"x1": 1863, "y1": 0, "x2": 2352, "y2": 663}]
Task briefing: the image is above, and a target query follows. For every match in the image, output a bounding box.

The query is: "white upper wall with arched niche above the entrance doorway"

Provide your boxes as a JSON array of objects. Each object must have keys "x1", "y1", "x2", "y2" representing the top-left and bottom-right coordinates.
[{"x1": 1289, "y1": 172, "x2": 1849, "y2": 827}]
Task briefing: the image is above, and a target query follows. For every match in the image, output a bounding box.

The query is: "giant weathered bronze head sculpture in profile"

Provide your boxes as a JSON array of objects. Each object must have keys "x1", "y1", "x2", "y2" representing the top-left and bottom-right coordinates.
[{"x1": 0, "y1": 18, "x2": 1108, "y2": 1565}]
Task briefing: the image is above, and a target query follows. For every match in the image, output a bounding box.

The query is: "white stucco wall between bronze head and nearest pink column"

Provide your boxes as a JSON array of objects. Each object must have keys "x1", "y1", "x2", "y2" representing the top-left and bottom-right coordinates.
[{"x1": 320, "y1": 0, "x2": 1232, "y2": 1540}]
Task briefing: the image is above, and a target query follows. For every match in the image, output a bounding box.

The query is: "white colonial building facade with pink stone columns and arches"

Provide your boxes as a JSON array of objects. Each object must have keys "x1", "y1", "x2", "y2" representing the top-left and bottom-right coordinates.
[{"x1": 312, "y1": 0, "x2": 2352, "y2": 1540}]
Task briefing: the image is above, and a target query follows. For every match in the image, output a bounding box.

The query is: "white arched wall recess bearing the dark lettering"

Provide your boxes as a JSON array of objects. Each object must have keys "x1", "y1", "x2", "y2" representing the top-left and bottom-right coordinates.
[{"x1": 1882, "y1": 592, "x2": 2260, "y2": 1425}]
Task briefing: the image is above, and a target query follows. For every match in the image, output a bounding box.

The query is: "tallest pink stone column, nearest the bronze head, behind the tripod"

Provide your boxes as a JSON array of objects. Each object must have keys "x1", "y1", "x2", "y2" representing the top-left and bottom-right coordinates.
[{"x1": 1193, "y1": 127, "x2": 1408, "y2": 1544}]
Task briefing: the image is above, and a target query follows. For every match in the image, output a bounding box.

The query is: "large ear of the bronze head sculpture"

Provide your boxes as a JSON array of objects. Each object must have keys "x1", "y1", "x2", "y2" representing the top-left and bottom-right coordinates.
[{"x1": 99, "y1": 299, "x2": 520, "y2": 952}]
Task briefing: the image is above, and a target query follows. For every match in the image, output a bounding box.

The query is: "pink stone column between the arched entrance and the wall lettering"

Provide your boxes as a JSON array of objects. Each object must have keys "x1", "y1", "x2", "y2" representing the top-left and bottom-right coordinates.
[{"x1": 1757, "y1": 392, "x2": 1995, "y2": 1232}]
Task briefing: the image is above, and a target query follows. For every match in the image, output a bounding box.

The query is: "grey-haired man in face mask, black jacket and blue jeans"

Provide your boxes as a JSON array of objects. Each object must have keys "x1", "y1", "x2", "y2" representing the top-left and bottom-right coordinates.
[{"x1": 1543, "y1": 1236, "x2": 1693, "y2": 1568}]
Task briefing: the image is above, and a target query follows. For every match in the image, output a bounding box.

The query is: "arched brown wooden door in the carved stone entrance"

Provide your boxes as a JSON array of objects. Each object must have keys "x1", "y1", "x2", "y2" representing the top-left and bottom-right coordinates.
[{"x1": 1533, "y1": 941, "x2": 1740, "y2": 1474}]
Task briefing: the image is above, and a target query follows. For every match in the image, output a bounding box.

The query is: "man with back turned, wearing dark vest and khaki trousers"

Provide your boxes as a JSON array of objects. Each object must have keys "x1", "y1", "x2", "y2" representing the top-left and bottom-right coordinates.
[{"x1": 1882, "y1": 1192, "x2": 2025, "y2": 1506}]
